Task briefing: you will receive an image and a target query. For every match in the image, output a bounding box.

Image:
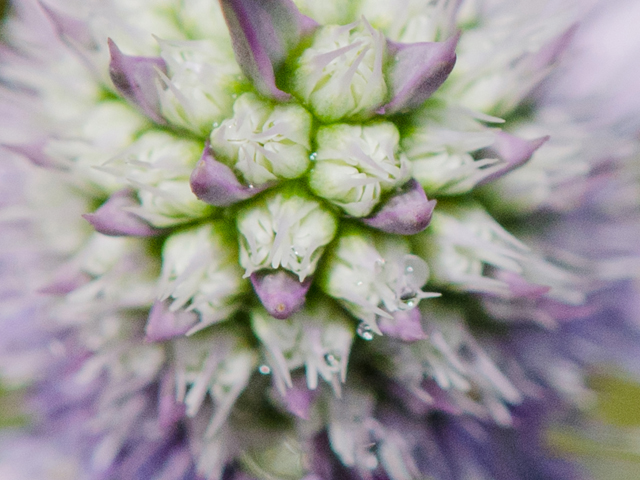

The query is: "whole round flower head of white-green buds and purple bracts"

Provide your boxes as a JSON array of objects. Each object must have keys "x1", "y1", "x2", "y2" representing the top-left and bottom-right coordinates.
[{"x1": 0, "y1": 0, "x2": 638, "y2": 480}]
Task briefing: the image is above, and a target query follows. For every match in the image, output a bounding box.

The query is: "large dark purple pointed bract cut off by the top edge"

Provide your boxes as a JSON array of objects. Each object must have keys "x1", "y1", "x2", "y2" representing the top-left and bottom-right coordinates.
[{"x1": 220, "y1": 0, "x2": 317, "y2": 101}]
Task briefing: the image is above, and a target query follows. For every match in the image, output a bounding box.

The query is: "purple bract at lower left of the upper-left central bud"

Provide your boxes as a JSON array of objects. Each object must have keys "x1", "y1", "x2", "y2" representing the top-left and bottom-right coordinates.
[{"x1": 190, "y1": 143, "x2": 269, "y2": 207}]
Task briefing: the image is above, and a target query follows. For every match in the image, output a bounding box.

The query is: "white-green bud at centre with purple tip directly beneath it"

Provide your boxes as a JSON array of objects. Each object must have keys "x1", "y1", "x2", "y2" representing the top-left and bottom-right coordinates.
[{"x1": 237, "y1": 191, "x2": 337, "y2": 282}]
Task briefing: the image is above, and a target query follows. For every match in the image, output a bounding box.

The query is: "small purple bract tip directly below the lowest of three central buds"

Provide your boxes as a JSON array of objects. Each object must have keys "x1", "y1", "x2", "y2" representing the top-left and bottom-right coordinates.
[{"x1": 251, "y1": 269, "x2": 312, "y2": 319}]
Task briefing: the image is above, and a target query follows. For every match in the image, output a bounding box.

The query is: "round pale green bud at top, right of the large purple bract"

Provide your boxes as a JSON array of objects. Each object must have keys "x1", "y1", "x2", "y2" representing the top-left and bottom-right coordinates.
[{"x1": 292, "y1": 19, "x2": 388, "y2": 123}]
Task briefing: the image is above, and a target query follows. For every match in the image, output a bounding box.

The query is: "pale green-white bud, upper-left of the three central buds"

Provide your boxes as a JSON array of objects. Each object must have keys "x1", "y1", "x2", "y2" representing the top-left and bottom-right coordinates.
[{"x1": 211, "y1": 93, "x2": 311, "y2": 185}]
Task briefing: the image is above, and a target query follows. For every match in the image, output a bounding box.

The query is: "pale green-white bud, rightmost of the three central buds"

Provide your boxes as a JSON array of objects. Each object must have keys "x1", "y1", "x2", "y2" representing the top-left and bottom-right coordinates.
[{"x1": 309, "y1": 122, "x2": 409, "y2": 217}]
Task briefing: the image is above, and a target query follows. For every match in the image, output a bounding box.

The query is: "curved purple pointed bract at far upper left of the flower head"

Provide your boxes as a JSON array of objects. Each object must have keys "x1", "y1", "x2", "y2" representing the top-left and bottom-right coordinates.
[{"x1": 108, "y1": 39, "x2": 167, "y2": 124}]
